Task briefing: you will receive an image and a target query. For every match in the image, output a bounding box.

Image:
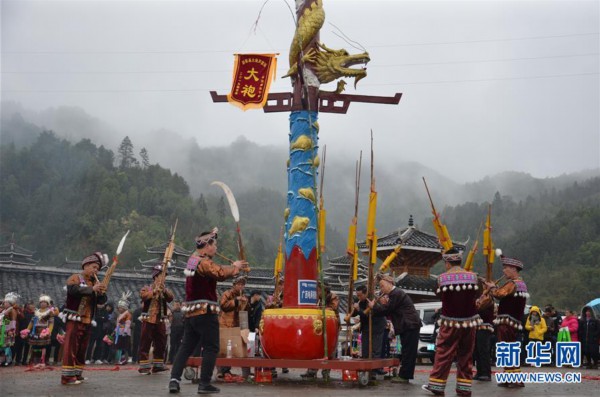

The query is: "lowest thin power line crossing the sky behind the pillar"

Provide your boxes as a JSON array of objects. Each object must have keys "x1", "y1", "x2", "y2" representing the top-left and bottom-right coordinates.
[{"x1": 2, "y1": 72, "x2": 600, "y2": 94}]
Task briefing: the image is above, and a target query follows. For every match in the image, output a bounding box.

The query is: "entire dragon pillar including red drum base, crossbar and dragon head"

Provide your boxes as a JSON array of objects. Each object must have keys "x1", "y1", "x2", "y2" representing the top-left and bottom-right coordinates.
[{"x1": 210, "y1": 0, "x2": 402, "y2": 360}]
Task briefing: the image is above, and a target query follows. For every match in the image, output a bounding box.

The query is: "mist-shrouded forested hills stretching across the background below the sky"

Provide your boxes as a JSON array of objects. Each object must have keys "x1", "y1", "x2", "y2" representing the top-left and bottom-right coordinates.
[{"x1": 0, "y1": 115, "x2": 600, "y2": 308}]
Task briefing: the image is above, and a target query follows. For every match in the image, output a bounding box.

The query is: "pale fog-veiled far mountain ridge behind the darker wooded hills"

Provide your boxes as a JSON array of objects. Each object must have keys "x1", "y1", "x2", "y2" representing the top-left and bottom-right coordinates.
[{"x1": 0, "y1": 103, "x2": 600, "y2": 240}]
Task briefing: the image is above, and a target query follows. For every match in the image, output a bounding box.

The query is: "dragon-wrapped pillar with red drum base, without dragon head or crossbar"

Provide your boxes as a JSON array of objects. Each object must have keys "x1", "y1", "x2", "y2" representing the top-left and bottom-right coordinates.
[{"x1": 262, "y1": 0, "x2": 339, "y2": 359}]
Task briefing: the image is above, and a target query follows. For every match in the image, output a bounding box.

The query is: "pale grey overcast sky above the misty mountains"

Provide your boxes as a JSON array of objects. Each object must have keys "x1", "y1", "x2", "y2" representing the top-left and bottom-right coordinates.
[{"x1": 1, "y1": 0, "x2": 600, "y2": 182}]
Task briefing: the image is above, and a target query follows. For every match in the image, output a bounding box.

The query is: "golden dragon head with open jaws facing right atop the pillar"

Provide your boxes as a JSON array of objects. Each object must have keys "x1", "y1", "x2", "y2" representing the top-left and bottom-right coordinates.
[{"x1": 315, "y1": 44, "x2": 371, "y2": 88}]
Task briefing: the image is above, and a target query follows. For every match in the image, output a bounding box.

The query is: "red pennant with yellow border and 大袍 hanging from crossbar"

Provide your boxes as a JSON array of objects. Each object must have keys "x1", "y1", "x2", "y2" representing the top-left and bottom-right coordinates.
[{"x1": 227, "y1": 54, "x2": 277, "y2": 111}]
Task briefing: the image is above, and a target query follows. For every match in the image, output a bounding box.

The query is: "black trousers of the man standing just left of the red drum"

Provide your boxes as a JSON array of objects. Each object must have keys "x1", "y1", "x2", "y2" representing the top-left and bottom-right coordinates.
[{"x1": 171, "y1": 314, "x2": 219, "y2": 386}]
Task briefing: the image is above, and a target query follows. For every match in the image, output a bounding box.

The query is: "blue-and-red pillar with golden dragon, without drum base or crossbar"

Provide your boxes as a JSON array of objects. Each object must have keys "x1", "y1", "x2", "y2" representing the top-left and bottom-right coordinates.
[{"x1": 284, "y1": 0, "x2": 370, "y2": 307}]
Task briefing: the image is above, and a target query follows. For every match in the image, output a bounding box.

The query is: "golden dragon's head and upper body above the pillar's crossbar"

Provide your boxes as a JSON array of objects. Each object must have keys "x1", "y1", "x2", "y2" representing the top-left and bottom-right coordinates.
[{"x1": 283, "y1": 0, "x2": 370, "y2": 93}]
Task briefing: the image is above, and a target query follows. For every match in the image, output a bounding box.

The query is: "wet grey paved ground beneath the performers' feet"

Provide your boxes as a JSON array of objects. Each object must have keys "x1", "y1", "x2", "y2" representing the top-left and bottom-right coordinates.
[{"x1": 0, "y1": 365, "x2": 600, "y2": 397}]
